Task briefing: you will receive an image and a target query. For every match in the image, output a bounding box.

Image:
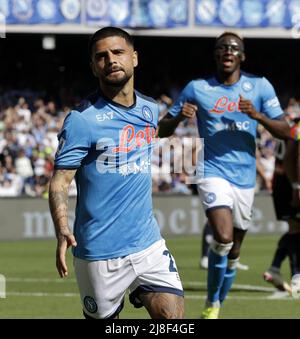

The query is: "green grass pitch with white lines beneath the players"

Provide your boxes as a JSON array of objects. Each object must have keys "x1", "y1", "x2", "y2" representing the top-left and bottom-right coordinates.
[{"x1": 0, "y1": 235, "x2": 300, "y2": 319}]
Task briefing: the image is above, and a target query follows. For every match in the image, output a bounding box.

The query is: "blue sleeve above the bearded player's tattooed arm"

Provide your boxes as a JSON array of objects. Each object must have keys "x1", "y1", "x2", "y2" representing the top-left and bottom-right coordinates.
[{"x1": 54, "y1": 111, "x2": 91, "y2": 169}]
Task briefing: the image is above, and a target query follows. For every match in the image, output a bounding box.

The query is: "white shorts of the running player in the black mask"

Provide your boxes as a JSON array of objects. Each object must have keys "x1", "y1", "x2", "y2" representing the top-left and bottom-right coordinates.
[{"x1": 198, "y1": 177, "x2": 255, "y2": 231}]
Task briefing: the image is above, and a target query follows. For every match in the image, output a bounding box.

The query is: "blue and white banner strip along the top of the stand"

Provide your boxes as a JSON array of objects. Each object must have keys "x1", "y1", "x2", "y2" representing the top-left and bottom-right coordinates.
[{"x1": 0, "y1": 0, "x2": 300, "y2": 28}]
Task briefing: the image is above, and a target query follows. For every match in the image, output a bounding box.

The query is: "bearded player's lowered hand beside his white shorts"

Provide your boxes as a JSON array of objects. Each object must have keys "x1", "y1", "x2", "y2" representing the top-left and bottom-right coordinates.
[{"x1": 56, "y1": 233, "x2": 77, "y2": 278}]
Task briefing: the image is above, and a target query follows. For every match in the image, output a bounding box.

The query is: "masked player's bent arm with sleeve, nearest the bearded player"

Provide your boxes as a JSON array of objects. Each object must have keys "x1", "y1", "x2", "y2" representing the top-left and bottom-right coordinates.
[{"x1": 157, "y1": 82, "x2": 197, "y2": 138}]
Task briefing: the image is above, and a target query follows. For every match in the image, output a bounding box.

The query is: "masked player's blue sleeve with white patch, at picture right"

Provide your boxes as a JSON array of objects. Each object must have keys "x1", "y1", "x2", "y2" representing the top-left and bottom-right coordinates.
[{"x1": 261, "y1": 78, "x2": 284, "y2": 119}]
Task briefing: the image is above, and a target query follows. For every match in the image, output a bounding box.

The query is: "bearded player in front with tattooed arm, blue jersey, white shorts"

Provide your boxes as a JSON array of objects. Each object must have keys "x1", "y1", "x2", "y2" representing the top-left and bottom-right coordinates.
[{"x1": 49, "y1": 27, "x2": 184, "y2": 319}]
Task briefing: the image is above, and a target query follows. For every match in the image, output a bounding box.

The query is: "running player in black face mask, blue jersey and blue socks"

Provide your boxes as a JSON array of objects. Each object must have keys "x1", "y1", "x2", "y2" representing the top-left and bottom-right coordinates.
[{"x1": 159, "y1": 32, "x2": 289, "y2": 319}]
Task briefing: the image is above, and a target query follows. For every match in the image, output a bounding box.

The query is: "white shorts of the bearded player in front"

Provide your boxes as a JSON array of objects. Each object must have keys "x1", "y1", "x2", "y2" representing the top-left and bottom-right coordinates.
[{"x1": 74, "y1": 239, "x2": 183, "y2": 319}]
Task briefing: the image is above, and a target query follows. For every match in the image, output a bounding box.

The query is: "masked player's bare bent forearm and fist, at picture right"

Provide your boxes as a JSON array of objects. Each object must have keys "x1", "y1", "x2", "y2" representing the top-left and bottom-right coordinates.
[{"x1": 239, "y1": 96, "x2": 290, "y2": 139}]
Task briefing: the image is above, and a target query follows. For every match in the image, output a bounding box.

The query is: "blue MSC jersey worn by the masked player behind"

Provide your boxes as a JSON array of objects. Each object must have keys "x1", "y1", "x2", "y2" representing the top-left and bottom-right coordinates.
[{"x1": 169, "y1": 73, "x2": 283, "y2": 188}]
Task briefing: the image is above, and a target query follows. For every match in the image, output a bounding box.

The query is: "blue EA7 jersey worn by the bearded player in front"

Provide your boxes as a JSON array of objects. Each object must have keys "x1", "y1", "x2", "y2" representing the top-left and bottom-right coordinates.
[{"x1": 55, "y1": 92, "x2": 161, "y2": 260}]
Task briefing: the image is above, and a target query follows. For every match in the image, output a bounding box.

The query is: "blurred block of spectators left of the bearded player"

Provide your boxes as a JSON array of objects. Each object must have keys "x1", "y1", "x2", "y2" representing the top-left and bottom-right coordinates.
[{"x1": 0, "y1": 97, "x2": 69, "y2": 198}]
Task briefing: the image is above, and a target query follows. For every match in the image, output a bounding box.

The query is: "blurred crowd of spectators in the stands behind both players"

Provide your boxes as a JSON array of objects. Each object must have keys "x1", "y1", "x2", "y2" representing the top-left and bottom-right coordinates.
[{"x1": 0, "y1": 95, "x2": 300, "y2": 198}]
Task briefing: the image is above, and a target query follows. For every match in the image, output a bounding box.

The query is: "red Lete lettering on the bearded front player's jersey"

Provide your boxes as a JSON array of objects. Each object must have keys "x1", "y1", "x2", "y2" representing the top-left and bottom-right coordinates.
[{"x1": 112, "y1": 124, "x2": 155, "y2": 153}]
